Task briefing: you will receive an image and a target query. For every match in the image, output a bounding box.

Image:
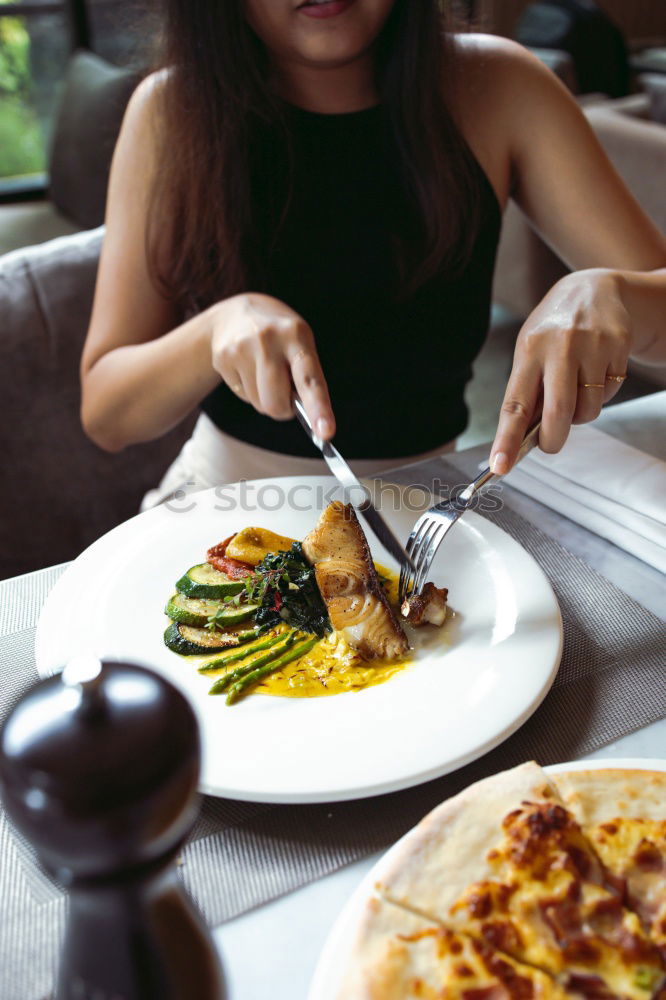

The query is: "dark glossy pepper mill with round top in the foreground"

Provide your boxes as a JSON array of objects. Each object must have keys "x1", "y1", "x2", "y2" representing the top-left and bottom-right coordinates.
[{"x1": 0, "y1": 657, "x2": 224, "y2": 1000}]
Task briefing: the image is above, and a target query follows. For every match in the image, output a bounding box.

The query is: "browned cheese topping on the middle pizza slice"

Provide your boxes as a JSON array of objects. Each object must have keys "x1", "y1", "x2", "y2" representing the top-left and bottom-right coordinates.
[{"x1": 452, "y1": 803, "x2": 664, "y2": 1000}]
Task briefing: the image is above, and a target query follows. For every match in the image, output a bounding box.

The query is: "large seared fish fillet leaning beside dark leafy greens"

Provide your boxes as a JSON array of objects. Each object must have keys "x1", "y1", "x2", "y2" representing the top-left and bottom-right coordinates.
[{"x1": 303, "y1": 500, "x2": 409, "y2": 659}]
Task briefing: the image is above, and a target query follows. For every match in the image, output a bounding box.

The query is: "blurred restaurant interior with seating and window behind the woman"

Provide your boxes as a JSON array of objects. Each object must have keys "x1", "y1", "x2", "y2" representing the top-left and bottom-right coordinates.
[{"x1": 0, "y1": 0, "x2": 666, "y2": 578}]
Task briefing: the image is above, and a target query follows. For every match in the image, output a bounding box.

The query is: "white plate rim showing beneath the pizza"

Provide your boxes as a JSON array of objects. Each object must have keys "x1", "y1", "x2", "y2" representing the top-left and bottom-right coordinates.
[{"x1": 307, "y1": 757, "x2": 666, "y2": 1000}]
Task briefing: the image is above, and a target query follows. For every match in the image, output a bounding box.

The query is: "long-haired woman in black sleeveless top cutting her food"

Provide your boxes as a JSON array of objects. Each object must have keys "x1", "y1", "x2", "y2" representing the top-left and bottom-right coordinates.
[{"x1": 81, "y1": 0, "x2": 666, "y2": 500}]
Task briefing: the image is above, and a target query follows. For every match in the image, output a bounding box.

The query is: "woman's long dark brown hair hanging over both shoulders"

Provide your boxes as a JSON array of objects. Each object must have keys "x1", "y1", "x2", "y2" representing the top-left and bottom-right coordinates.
[{"x1": 147, "y1": 0, "x2": 479, "y2": 310}]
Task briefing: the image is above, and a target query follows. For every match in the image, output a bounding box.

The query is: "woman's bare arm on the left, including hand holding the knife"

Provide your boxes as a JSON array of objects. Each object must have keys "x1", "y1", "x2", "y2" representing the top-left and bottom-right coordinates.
[{"x1": 81, "y1": 76, "x2": 335, "y2": 451}]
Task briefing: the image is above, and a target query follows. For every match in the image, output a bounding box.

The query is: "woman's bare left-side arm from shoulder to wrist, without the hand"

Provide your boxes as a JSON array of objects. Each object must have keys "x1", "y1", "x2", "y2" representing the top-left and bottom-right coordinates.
[{"x1": 81, "y1": 76, "x2": 220, "y2": 451}]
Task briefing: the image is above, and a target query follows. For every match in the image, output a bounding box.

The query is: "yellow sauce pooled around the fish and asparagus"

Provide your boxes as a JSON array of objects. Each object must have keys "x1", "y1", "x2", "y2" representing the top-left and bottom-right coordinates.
[{"x1": 187, "y1": 564, "x2": 452, "y2": 698}]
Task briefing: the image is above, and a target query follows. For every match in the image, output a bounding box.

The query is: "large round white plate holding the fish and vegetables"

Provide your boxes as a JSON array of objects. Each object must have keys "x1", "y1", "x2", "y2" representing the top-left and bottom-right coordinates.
[{"x1": 36, "y1": 476, "x2": 562, "y2": 802}]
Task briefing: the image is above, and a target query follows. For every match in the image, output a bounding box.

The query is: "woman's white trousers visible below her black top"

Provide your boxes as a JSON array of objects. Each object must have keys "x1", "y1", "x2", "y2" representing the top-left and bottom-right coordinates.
[{"x1": 141, "y1": 413, "x2": 455, "y2": 510}]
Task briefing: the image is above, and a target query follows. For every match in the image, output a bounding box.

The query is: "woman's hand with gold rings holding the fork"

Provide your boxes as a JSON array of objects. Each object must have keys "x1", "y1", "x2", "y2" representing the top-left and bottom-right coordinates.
[{"x1": 490, "y1": 268, "x2": 632, "y2": 475}]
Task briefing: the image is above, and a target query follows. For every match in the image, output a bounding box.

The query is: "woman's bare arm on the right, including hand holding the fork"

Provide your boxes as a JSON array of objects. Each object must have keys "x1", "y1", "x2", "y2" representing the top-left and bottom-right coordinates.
[{"x1": 456, "y1": 37, "x2": 666, "y2": 472}]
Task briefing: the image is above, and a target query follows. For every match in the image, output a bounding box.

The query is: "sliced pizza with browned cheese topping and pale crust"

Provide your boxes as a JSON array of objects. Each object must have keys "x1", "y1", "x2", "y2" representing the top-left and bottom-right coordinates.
[{"x1": 339, "y1": 762, "x2": 666, "y2": 1000}]
